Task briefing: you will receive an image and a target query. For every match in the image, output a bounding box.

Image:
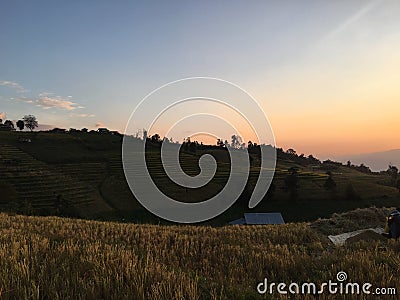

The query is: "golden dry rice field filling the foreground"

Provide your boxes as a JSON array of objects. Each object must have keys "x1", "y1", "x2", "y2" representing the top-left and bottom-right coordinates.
[{"x1": 0, "y1": 214, "x2": 400, "y2": 299}]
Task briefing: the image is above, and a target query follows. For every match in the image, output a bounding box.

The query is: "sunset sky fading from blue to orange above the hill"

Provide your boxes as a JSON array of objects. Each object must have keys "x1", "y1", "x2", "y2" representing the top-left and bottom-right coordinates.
[{"x1": 0, "y1": 0, "x2": 400, "y2": 157}]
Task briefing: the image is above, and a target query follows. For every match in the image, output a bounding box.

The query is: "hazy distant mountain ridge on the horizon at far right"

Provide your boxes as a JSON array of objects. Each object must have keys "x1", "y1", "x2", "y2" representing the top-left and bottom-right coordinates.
[{"x1": 333, "y1": 149, "x2": 400, "y2": 171}]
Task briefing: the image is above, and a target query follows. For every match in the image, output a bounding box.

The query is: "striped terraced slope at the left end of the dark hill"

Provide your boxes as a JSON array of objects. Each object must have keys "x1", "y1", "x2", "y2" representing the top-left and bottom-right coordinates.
[{"x1": 0, "y1": 144, "x2": 110, "y2": 216}]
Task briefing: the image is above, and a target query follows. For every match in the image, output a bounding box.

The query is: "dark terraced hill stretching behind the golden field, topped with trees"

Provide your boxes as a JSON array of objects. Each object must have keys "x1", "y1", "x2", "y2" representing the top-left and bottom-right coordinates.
[{"x1": 0, "y1": 132, "x2": 400, "y2": 225}]
